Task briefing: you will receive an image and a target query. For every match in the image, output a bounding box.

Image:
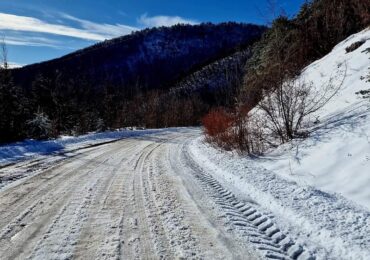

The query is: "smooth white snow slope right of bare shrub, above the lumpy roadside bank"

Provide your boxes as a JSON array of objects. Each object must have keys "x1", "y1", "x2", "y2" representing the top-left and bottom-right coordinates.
[{"x1": 260, "y1": 29, "x2": 370, "y2": 209}]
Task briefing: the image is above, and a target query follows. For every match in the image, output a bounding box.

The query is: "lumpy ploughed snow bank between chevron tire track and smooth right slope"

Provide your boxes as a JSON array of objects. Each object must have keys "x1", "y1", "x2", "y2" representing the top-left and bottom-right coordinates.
[{"x1": 188, "y1": 138, "x2": 370, "y2": 260}]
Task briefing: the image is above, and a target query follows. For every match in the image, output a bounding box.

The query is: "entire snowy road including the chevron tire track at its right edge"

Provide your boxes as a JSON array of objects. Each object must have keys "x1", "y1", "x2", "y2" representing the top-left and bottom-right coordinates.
[{"x1": 0, "y1": 129, "x2": 366, "y2": 259}]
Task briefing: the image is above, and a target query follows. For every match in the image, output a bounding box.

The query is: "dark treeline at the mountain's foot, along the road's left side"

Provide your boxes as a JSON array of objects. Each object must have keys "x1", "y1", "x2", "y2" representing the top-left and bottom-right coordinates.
[{"x1": 0, "y1": 67, "x2": 205, "y2": 142}]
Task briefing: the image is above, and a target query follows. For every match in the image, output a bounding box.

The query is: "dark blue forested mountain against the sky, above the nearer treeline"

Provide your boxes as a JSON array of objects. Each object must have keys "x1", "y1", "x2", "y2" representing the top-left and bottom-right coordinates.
[{"x1": 13, "y1": 23, "x2": 266, "y2": 92}]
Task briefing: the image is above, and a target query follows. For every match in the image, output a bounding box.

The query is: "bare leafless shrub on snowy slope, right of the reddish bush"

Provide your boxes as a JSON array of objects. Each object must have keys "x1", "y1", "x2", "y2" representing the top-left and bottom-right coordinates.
[{"x1": 253, "y1": 65, "x2": 347, "y2": 145}]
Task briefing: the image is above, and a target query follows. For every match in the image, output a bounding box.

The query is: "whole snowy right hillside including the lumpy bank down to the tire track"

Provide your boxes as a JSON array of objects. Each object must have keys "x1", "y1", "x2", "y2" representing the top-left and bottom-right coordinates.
[{"x1": 189, "y1": 29, "x2": 370, "y2": 260}]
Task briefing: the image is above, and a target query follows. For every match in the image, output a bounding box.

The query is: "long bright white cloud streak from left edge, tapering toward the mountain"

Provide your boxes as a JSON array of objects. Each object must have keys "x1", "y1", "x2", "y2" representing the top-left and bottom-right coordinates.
[{"x1": 0, "y1": 13, "x2": 136, "y2": 41}]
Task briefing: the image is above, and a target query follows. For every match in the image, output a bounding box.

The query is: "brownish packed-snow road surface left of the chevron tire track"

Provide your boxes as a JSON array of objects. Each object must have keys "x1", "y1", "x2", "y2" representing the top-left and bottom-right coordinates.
[{"x1": 0, "y1": 131, "x2": 256, "y2": 259}]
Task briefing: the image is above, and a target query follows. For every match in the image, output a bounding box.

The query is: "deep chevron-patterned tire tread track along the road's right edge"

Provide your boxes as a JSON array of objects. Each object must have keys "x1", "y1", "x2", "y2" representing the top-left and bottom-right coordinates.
[{"x1": 183, "y1": 143, "x2": 315, "y2": 260}]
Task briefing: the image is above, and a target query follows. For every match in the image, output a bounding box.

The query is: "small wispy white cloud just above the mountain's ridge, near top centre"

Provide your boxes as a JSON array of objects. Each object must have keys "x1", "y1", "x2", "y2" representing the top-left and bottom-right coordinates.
[{"x1": 138, "y1": 14, "x2": 198, "y2": 27}]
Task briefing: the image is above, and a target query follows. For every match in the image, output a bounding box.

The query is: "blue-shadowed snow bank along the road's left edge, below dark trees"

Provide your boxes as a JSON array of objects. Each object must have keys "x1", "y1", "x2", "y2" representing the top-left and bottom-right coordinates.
[{"x1": 0, "y1": 129, "x2": 169, "y2": 166}]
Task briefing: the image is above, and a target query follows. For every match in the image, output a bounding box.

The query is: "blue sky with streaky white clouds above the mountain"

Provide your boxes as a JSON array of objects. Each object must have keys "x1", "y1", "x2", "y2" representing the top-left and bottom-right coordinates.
[{"x1": 0, "y1": 0, "x2": 304, "y2": 65}]
